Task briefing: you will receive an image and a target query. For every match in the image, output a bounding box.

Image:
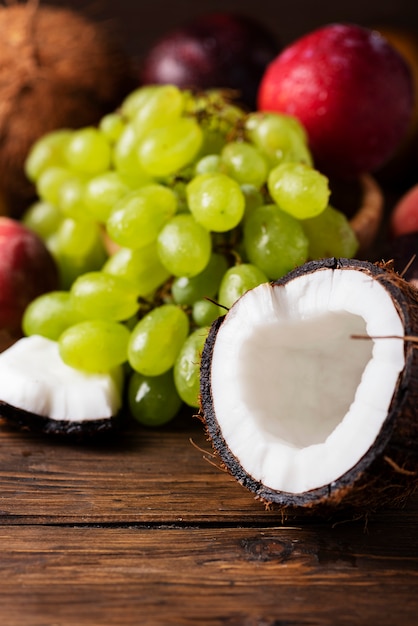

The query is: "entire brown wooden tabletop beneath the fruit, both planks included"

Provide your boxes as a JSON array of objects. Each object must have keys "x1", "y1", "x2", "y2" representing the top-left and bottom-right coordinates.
[{"x1": 0, "y1": 415, "x2": 418, "y2": 626}]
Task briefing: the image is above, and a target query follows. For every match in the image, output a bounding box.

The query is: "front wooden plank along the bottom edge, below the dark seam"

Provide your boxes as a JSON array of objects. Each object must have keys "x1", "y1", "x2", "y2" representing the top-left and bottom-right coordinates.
[{"x1": 0, "y1": 522, "x2": 418, "y2": 626}]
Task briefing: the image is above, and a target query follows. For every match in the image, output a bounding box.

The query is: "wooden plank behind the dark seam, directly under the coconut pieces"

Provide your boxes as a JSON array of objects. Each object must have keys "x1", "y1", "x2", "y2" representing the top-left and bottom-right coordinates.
[{"x1": 0, "y1": 416, "x2": 418, "y2": 524}]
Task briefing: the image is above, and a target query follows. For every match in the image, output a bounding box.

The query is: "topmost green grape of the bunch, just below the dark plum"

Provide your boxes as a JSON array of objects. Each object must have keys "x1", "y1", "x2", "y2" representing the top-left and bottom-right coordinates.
[{"x1": 132, "y1": 85, "x2": 184, "y2": 137}]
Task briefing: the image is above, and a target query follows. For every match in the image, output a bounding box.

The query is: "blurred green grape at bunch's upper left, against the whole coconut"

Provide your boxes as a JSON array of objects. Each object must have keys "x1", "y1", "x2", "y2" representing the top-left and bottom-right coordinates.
[{"x1": 24, "y1": 129, "x2": 72, "y2": 182}]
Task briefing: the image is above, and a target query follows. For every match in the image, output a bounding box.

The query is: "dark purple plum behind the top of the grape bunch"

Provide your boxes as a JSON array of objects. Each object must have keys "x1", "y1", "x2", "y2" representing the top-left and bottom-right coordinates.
[{"x1": 141, "y1": 13, "x2": 280, "y2": 109}]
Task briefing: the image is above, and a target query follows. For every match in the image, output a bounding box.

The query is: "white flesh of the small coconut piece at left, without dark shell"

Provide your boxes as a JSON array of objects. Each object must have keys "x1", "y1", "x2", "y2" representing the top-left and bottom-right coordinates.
[{"x1": 0, "y1": 335, "x2": 122, "y2": 422}]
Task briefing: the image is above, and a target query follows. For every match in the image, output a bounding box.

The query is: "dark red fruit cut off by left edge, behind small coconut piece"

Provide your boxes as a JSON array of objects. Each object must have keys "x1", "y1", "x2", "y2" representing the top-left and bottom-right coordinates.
[{"x1": 0, "y1": 217, "x2": 59, "y2": 350}]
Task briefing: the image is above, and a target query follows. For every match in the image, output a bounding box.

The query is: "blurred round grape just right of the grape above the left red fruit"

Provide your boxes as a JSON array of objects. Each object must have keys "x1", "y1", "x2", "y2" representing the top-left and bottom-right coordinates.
[{"x1": 55, "y1": 217, "x2": 101, "y2": 257}]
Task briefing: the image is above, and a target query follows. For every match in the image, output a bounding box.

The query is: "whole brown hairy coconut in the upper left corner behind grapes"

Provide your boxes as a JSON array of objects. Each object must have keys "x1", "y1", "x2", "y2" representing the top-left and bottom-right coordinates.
[{"x1": 0, "y1": 2, "x2": 134, "y2": 216}]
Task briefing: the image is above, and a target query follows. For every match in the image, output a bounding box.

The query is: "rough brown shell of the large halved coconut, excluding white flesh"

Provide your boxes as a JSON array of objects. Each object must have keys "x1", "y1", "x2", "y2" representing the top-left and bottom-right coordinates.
[{"x1": 200, "y1": 258, "x2": 418, "y2": 516}]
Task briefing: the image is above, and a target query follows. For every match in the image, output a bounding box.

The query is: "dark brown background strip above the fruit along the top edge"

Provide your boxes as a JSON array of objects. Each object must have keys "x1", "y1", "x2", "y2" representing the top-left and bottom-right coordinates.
[{"x1": 48, "y1": 0, "x2": 418, "y2": 59}]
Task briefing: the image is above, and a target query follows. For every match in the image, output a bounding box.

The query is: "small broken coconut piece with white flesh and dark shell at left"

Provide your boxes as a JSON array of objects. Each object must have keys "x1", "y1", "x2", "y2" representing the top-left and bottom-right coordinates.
[{"x1": 0, "y1": 335, "x2": 122, "y2": 438}]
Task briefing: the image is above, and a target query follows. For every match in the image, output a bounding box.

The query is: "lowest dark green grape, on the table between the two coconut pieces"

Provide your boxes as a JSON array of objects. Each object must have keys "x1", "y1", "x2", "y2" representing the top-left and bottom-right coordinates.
[{"x1": 128, "y1": 369, "x2": 183, "y2": 427}]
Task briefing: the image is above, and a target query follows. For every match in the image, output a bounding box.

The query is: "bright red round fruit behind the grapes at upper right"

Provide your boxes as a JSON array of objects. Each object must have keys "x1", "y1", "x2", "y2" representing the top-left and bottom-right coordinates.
[{"x1": 258, "y1": 24, "x2": 414, "y2": 178}]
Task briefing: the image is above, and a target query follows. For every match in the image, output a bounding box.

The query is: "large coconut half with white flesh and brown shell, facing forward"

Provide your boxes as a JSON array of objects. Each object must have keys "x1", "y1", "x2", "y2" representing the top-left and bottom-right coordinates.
[{"x1": 201, "y1": 259, "x2": 418, "y2": 511}]
